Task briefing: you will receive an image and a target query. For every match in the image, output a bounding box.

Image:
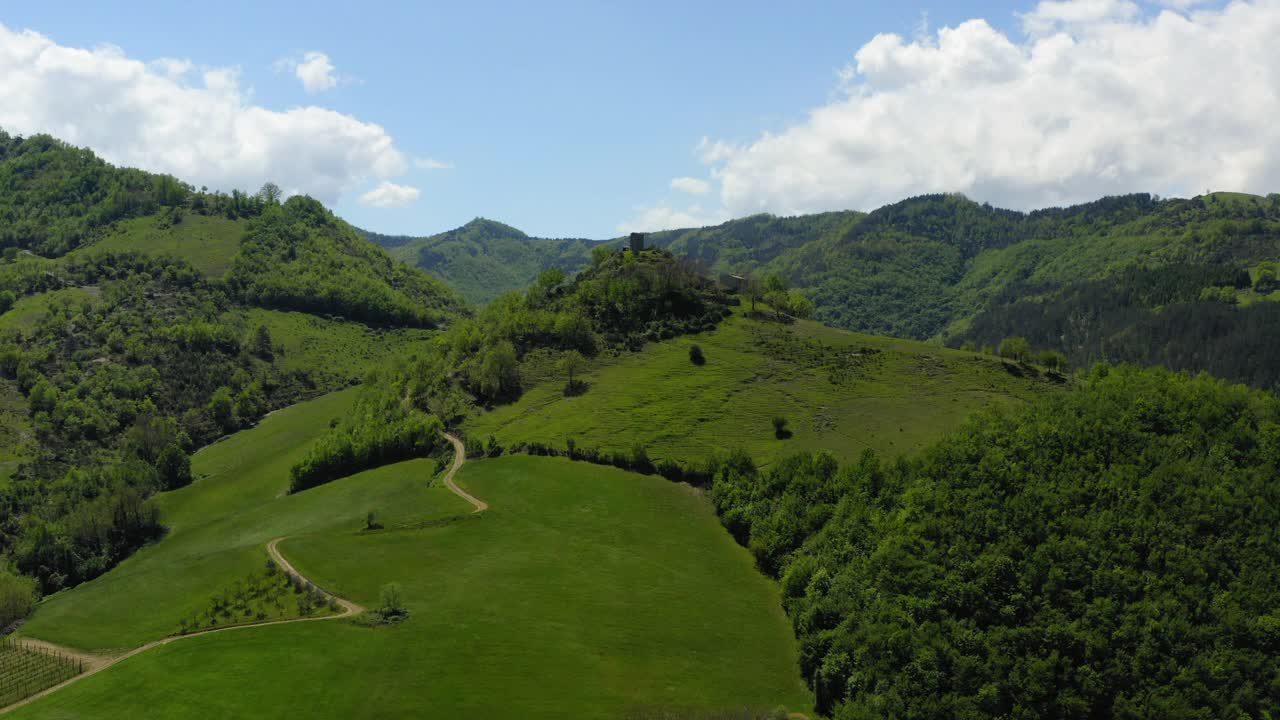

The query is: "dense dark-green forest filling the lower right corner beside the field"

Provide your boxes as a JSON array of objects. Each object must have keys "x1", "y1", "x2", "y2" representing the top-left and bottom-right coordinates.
[{"x1": 712, "y1": 366, "x2": 1280, "y2": 719}]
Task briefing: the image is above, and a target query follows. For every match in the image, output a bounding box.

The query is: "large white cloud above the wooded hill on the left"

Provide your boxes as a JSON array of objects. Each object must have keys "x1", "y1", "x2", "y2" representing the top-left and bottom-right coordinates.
[{"x1": 0, "y1": 26, "x2": 407, "y2": 204}]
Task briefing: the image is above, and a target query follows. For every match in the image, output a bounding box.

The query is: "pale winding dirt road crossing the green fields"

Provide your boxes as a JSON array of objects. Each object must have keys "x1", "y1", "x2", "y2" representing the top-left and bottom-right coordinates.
[{"x1": 0, "y1": 433, "x2": 489, "y2": 715}]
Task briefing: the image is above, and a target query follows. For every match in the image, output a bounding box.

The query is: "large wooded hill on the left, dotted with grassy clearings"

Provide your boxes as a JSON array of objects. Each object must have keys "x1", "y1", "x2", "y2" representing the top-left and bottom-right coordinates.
[{"x1": 0, "y1": 132, "x2": 468, "y2": 604}]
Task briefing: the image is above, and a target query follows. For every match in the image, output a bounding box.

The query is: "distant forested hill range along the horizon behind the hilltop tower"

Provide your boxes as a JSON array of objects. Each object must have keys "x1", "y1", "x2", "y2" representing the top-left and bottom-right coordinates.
[{"x1": 378, "y1": 193, "x2": 1280, "y2": 387}]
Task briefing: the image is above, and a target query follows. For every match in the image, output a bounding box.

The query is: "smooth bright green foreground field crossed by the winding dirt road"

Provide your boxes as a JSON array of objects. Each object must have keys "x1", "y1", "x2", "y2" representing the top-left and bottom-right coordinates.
[{"x1": 14, "y1": 393, "x2": 812, "y2": 717}]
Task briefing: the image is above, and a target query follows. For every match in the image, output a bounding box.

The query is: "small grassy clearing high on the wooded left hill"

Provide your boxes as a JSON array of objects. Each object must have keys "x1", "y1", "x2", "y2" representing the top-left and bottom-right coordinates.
[{"x1": 72, "y1": 213, "x2": 244, "y2": 278}]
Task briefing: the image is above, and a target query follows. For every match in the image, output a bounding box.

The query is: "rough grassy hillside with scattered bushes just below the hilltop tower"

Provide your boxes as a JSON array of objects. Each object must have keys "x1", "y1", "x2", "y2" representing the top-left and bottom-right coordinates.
[{"x1": 465, "y1": 307, "x2": 1056, "y2": 464}]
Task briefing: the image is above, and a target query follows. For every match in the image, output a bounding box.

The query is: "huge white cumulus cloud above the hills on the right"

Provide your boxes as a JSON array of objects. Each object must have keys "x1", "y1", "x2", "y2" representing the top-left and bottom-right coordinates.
[{"x1": 665, "y1": 0, "x2": 1280, "y2": 217}]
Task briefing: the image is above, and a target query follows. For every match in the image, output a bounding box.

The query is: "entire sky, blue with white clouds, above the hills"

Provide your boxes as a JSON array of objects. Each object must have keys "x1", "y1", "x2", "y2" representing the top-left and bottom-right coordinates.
[{"x1": 0, "y1": 0, "x2": 1259, "y2": 238}]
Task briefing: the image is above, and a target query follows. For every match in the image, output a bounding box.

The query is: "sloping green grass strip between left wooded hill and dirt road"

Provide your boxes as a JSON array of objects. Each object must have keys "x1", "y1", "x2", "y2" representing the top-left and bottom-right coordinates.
[{"x1": 22, "y1": 389, "x2": 366, "y2": 651}]
